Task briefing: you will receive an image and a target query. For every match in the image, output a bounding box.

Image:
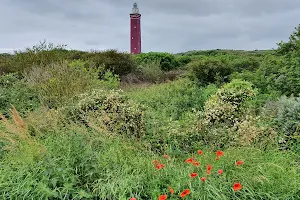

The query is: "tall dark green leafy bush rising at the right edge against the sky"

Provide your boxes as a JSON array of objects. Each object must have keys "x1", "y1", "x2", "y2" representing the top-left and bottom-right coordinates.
[{"x1": 232, "y1": 26, "x2": 300, "y2": 96}]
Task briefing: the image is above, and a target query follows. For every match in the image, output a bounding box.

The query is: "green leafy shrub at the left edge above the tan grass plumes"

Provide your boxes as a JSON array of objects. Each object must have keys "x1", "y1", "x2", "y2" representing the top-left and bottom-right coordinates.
[{"x1": 0, "y1": 73, "x2": 40, "y2": 117}]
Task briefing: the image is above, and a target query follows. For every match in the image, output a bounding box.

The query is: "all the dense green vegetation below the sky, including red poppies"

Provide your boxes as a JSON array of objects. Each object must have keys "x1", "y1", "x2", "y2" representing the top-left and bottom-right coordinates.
[{"x1": 0, "y1": 26, "x2": 300, "y2": 200}]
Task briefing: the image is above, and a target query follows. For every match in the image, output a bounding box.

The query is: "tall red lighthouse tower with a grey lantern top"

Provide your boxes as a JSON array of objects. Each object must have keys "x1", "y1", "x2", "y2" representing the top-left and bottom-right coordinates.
[{"x1": 130, "y1": 3, "x2": 142, "y2": 54}]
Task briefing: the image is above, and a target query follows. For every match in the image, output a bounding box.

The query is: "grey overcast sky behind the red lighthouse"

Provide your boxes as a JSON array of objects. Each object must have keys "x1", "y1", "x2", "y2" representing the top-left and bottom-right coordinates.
[{"x1": 0, "y1": 0, "x2": 300, "y2": 53}]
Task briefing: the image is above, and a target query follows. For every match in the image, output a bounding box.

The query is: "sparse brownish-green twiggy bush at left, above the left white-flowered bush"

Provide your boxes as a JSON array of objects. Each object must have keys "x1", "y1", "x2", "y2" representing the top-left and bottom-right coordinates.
[{"x1": 24, "y1": 62, "x2": 100, "y2": 107}]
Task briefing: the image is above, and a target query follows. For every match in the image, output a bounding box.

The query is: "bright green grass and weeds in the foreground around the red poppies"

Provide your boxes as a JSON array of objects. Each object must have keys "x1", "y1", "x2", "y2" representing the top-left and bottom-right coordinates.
[{"x1": 0, "y1": 124, "x2": 300, "y2": 199}]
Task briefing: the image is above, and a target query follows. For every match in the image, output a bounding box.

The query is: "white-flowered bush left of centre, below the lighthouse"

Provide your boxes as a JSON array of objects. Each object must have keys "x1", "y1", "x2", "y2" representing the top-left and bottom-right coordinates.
[{"x1": 65, "y1": 89, "x2": 144, "y2": 138}]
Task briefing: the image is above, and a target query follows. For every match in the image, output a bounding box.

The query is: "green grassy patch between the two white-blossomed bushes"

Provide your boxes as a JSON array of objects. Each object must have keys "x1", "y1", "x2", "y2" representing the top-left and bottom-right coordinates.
[{"x1": 126, "y1": 78, "x2": 217, "y2": 152}]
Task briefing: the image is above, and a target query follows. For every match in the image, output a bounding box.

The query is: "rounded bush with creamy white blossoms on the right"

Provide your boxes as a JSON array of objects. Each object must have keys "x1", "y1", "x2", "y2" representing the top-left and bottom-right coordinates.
[{"x1": 203, "y1": 79, "x2": 257, "y2": 125}]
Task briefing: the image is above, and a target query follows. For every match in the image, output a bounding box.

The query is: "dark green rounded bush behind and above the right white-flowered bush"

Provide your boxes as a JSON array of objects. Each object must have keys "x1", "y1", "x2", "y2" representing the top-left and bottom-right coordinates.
[{"x1": 187, "y1": 58, "x2": 232, "y2": 85}]
